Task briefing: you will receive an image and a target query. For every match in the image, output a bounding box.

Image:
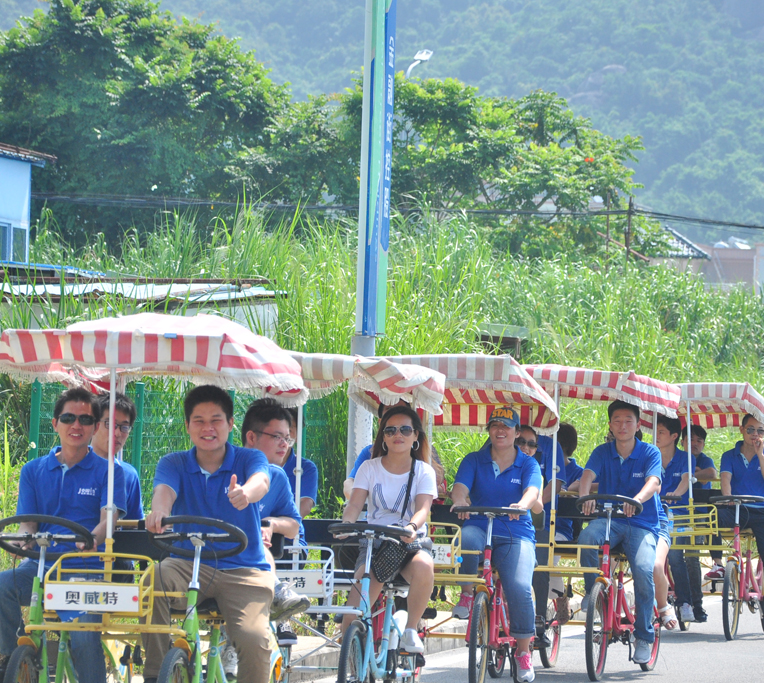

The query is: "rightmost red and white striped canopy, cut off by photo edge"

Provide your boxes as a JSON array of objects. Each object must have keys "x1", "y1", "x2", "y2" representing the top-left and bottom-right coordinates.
[{"x1": 679, "y1": 382, "x2": 764, "y2": 429}]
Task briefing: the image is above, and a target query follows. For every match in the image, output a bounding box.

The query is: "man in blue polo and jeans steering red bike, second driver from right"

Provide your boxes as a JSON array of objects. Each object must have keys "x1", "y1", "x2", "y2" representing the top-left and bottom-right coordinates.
[{"x1": 578, "y1": 401, "x2": 661, "y2": 664}]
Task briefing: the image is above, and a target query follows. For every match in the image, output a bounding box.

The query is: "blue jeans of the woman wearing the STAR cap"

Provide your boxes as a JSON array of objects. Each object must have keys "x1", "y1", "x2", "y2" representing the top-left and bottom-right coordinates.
[{"x1": 461, "y1": 525, "x2": 536, "y2": 639}]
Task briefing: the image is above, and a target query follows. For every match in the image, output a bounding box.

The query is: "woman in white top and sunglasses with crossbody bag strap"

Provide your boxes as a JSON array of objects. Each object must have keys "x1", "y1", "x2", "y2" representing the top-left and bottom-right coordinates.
[{"x1": 342, "y1": 406, "x2": 438, "y2": 653}]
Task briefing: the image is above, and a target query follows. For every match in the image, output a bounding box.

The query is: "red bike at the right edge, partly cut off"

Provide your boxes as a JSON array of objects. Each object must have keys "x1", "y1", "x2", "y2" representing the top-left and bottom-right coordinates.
[{"x1": 709, "y1": 496, "x2": 764, "y2": 640}]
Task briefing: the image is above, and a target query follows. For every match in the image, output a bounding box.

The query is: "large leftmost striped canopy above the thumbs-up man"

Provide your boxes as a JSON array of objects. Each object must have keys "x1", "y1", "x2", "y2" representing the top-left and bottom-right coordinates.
[{"x1": 0, "y1": 313, "x2": 308, "y2": 406}]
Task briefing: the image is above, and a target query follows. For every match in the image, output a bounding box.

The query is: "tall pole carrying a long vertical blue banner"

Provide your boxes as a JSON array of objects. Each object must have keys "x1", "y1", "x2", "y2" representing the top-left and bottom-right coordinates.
[{"x1": 347, "y1": 0, "x2": 397, "y2": 471}]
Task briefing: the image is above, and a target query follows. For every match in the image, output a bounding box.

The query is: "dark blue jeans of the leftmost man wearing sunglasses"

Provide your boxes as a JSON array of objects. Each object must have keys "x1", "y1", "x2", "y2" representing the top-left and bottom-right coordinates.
[{"x1": 0, "y1": 560, "x2": 106, "y2": 683}]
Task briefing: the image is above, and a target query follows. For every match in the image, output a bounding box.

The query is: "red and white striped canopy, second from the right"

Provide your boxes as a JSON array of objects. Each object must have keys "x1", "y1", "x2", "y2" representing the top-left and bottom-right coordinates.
[{"x1": 523, "y1": 364, "x2": 681, "y2": 429}]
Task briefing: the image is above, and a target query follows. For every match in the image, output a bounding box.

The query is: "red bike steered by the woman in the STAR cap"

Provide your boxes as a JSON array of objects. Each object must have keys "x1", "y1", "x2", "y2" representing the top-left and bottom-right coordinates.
[{"x1": 454, "y1": 506, "x2": 527, "y2": 683}]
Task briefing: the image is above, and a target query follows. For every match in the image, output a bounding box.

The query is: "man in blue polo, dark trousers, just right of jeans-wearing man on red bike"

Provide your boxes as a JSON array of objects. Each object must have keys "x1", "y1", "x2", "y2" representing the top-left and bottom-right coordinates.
[{"x1": 655, "y1": 415, "x2": 703, "y2": 622}]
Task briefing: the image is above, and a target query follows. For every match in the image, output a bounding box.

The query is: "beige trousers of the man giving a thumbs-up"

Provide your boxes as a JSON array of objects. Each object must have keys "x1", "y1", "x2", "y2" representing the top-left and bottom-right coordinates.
[{"x1": 143, "y1": 558, "x2": 274, "y2": 683}]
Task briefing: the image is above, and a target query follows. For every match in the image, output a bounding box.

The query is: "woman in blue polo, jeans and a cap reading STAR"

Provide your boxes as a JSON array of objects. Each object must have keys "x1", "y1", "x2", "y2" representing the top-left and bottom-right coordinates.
[{"x1": 451, "y1": 406, "x2": 542, "y2": 682}]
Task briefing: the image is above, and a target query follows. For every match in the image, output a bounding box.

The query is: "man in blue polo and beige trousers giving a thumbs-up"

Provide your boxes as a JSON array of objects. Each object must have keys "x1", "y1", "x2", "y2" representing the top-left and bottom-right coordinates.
[{"x1": 143, "y1": 386, "x2": 274, "y2": 683}]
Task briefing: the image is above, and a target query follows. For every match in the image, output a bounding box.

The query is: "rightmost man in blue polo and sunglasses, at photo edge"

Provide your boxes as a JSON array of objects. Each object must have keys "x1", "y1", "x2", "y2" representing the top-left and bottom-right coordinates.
[{"x1": 719, "y1": 415, "x2": 764, "y2": 552}]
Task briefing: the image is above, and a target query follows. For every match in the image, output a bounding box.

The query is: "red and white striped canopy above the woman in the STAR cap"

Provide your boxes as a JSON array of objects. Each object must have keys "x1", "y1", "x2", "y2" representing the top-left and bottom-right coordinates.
[{"x1": 380, "y1": 353, "x2": 559, "y2": 433}]
